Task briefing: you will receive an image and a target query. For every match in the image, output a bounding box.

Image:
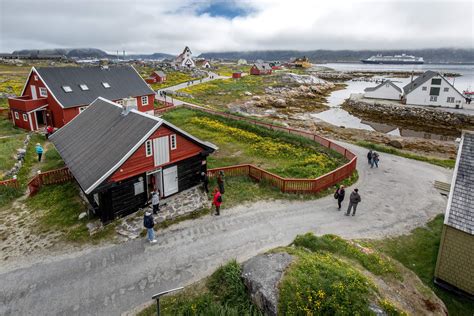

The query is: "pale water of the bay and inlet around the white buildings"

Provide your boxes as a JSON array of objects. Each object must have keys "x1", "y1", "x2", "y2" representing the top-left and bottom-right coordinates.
[{"x1": 312, "y1": 63, "x2": 474, "y2": 140}]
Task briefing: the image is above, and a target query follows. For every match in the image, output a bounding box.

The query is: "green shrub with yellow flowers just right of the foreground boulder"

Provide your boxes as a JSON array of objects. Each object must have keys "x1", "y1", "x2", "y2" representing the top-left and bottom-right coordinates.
[{"x1": 279, "y1": 252, "x2": 375, "y2": 315}]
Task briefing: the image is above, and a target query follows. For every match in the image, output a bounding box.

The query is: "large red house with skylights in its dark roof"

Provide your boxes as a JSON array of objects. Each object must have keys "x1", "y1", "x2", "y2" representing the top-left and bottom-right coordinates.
[{"x1": 8, "y1": 66, "x2": 155, "y2": 131}]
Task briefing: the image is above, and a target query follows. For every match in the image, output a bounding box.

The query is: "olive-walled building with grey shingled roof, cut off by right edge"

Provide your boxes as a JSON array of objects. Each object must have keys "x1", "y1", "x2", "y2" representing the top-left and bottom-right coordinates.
[{"x1": 435, "y1": 131, "x2": 474, "y2": 298}]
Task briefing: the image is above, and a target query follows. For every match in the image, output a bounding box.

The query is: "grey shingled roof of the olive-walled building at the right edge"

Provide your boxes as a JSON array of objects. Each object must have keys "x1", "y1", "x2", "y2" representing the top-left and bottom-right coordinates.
[{"x1": 445, "y1": 132, "x2": 474, "y2": 235}]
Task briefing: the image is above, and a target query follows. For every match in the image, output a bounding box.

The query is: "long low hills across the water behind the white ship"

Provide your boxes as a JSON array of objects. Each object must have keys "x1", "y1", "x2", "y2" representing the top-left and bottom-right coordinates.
[{"x1": 199, "y1": 48, "x2": 474, "y2": 63}]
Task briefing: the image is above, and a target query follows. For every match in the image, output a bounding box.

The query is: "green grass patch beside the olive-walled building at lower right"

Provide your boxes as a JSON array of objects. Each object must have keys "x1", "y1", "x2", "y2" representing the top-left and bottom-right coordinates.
[{"x1": 368, "y1": 215, "x2": 474, "y2": 316}]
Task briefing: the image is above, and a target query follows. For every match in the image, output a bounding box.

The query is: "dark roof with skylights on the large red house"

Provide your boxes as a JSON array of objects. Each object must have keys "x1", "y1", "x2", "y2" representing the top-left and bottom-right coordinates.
[{"x1": 36, "y1": 66, "x2": 155, "y2": 108}]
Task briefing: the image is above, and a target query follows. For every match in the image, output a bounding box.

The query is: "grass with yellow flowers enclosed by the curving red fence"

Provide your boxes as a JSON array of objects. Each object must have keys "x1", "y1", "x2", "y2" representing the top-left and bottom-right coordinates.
[{"x1": 163, "y1": 109, "x2": 346, "y2": 178}]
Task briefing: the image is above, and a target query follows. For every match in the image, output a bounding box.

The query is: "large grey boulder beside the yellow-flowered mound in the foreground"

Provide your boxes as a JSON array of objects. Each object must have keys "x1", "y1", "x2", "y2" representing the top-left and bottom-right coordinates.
[{"x1": 242, "y1": 253, "x2": 293, "y2": 315}]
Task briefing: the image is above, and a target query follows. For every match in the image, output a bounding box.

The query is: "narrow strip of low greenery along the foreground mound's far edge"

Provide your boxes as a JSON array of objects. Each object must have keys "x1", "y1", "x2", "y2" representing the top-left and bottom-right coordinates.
[{"x1": 293, "y1": 233, "x2": 398, "y2": 276}]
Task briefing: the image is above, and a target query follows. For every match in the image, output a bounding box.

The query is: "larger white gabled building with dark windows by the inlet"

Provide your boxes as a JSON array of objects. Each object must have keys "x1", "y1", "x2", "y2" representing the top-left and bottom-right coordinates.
[{"x1": 403, "y1": 70, "x2": 468, "y2": 110}]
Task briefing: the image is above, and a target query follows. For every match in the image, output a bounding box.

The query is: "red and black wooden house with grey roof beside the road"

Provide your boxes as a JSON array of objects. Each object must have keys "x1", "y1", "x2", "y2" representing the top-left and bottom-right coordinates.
[{"x1": 50, "y1": 98, "x2": 217, "y2": 222}]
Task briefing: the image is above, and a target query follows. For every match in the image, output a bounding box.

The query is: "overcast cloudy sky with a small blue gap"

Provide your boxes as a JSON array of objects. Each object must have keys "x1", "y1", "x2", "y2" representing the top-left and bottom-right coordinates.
[{"x1": 0, "y1": 0, "x2": 474, "y2": 54}]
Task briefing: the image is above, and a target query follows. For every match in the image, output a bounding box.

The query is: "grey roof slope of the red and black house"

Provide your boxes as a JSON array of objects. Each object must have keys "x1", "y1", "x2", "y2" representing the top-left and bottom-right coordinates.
[{"x1": 50, "y1": 99, "x2": 161, "y2": 192}]
